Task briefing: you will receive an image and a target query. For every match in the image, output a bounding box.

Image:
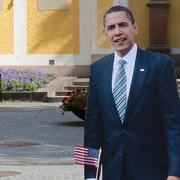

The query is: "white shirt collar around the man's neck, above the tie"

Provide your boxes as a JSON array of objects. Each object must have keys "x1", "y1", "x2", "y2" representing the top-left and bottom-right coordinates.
[{"x1": 114, "y1": 43, "x2": 137, "y2": 64}]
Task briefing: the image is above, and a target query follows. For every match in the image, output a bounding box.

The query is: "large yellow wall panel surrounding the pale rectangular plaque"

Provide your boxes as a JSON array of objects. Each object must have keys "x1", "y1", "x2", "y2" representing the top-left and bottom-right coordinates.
[{"x1": 27, "y1": 0, "x2": 79, "y2": 54}]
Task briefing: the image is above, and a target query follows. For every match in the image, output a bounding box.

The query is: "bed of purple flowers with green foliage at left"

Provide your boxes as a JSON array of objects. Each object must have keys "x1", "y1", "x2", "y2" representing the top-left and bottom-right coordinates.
[{"x1": 0, "y1": 69, "x2": 55, "y2": 92}]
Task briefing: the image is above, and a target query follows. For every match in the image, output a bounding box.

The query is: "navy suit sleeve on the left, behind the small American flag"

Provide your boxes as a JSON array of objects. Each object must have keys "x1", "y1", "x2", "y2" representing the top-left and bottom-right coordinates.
[{"x1": 84, "y1": 65, "x2": 102, "y2": 179}]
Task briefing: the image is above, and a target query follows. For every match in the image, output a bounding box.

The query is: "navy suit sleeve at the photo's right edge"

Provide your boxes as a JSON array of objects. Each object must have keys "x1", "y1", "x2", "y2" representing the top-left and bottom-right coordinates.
[{"x1": 160, "y1": 59, "x2": 180, "y2": 176}]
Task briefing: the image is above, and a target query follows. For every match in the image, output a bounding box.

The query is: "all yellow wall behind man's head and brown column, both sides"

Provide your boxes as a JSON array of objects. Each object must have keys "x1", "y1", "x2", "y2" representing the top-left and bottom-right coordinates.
[{"x1": 97, "y1": 0, "x2": 180, "y2": 48}]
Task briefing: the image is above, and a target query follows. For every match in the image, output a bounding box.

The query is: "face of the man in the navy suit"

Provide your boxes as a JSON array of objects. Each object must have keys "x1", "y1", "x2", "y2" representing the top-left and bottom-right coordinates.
[{"x1": 104, "y1": 11, "x2": 138, "y2": 57}]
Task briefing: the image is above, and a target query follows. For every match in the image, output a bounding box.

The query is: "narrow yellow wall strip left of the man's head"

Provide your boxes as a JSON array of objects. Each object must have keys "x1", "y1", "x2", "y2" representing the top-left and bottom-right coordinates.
[{"x1": 96, "y1": 0, "x2": 113, "y2": 48}]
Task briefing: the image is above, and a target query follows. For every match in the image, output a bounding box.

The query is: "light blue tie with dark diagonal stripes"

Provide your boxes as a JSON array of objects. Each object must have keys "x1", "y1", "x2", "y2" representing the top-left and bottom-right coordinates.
[{"x1": 113, "y1": 59, "x2": 127, "y2": 123}]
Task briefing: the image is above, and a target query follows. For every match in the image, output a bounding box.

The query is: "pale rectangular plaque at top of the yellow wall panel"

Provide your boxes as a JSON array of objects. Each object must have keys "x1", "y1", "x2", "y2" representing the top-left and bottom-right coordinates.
[{"x1": 38, "y1": 0, "x2": 68, "y2": 11}]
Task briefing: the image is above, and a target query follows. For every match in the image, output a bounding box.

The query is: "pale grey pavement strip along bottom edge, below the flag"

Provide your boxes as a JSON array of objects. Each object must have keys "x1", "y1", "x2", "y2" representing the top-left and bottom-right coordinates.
[{"x1": 0, "y1": 165, "x2": 83, "y2": 180}]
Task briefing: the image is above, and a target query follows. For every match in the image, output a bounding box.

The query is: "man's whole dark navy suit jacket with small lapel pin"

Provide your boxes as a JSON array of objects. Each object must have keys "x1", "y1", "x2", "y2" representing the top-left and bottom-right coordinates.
[{"x1": 84, "y1": 48, "x2": 180, "y2": 180}]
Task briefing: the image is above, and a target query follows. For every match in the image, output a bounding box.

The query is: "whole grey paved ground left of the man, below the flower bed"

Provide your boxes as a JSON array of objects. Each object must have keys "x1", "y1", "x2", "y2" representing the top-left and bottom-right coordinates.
[{"x1": 0, "y1": 102, "x2": 83, "y2": 180}]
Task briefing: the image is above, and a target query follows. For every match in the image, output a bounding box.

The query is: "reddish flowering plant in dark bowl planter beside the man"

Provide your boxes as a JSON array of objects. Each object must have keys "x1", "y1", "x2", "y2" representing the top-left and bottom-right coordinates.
[{"x1": 60, "y1": 89, "x2": 87, "y2": 120}]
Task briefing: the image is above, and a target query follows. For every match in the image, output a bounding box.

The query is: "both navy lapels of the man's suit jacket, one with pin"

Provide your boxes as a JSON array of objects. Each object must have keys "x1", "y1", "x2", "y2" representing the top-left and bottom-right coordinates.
[{"x1": 103, "y1": 49, "x2": 149, "y2": 125}]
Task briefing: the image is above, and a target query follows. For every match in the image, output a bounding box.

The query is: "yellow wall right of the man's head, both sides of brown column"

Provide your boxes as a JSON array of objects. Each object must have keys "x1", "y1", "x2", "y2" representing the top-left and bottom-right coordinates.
[{"x1": 129, "y1": 0, "x2": 180, "y2": 48}]
